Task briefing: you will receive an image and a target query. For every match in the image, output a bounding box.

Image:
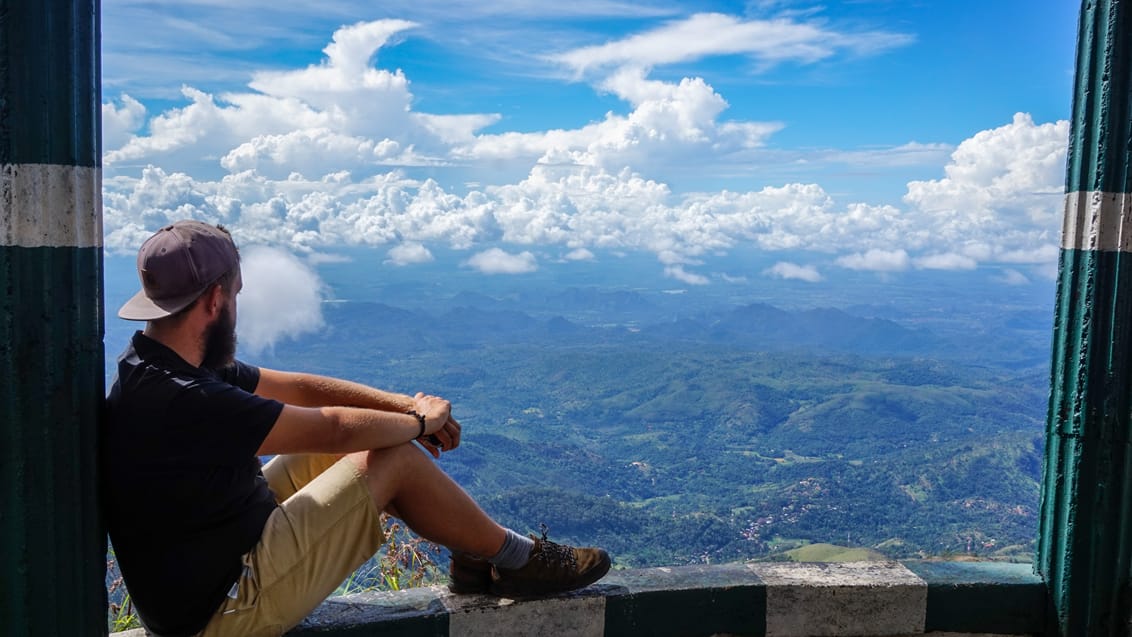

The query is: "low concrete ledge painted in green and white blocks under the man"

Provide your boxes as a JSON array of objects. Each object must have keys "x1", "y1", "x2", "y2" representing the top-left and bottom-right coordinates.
[{"x1": 115, "y1": 561, "x2": 1045, "y2": 637}]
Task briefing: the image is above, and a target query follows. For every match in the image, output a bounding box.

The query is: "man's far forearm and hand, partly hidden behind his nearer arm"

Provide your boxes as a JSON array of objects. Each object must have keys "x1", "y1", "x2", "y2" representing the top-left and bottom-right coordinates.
[{"x1": 256, "y1": 368, "x2": 461, "y2": 457}]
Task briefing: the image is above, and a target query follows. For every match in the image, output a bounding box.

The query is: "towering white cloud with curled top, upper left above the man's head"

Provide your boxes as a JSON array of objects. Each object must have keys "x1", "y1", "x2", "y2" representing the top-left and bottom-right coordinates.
[{"x1": 103, "y1": 20, "x2": 497, "y2": 177}]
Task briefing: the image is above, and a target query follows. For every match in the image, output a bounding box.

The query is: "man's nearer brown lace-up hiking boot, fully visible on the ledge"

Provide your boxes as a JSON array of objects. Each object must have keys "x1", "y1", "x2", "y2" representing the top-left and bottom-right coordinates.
[{"x1": 491, "y1": 525, "x2": 609, "y2": 600}]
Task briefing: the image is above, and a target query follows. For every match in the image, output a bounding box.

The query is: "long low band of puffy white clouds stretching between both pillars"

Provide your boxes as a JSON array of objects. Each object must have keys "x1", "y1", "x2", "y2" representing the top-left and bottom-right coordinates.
[{"x1": 104, "y1": 108, "x2": 1064, "y2": 282}]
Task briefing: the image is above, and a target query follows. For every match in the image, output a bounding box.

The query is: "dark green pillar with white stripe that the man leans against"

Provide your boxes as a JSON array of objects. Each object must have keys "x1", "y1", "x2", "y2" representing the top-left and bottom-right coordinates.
[{"x1": 0, "y1": 0, "x2": 106, "y2": 637}]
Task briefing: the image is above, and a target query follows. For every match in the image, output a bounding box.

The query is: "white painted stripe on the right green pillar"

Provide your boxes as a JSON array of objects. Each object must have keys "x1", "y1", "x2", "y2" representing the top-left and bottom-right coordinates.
[{"x1": 1062, "y1": 192, "x2": 1132, "y2": 252}]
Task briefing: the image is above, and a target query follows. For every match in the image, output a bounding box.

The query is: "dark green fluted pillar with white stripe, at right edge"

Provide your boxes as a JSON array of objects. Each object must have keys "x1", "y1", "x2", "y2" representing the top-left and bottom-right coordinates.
[{"x1": 1037, "y1": 0, "x2": 1132, "y2": 636}]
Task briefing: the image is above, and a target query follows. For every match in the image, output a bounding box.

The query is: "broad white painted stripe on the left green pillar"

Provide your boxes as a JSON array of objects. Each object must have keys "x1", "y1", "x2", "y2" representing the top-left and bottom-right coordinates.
[{"x1": 0, "y1": 164, "x2": 102, "y2": 248}]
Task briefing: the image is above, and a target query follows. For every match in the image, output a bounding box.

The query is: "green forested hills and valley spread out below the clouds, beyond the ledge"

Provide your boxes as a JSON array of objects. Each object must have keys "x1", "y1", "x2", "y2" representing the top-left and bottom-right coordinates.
[{"x1": 260, "y1": 304, "x2": 1047, "y2": 566}]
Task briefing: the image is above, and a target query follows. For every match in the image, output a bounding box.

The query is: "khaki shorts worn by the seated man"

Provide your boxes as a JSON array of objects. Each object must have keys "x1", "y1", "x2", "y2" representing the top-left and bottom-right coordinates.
[{"x1": 200, "y1": 455, "x2": 385, "y2": 637}]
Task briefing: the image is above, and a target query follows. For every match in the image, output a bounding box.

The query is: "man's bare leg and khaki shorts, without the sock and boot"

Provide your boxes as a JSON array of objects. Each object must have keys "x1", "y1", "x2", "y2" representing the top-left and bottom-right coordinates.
[{"x1": 204, "y1": 445, "x2": 506, "y2": 637}]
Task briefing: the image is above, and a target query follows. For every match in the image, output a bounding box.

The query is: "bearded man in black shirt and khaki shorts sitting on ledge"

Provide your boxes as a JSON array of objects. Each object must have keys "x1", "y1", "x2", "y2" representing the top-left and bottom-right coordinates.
[{"x1": 102, "y1": 221, "x2": 609, "y2": 637}]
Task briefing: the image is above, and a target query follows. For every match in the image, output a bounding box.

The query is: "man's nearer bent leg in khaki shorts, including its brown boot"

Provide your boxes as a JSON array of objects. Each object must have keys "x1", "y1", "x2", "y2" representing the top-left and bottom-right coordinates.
[{"x1": 203, "y1": 445, "x2": 609, "y2": 637}]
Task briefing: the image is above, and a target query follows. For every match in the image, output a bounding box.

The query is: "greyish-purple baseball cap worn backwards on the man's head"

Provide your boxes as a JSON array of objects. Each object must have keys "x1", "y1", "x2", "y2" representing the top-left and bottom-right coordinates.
[{"x1": 118, "y1": 221, "x2": 240, "y2": 320}]
